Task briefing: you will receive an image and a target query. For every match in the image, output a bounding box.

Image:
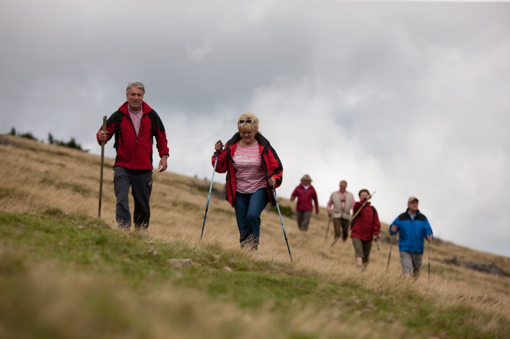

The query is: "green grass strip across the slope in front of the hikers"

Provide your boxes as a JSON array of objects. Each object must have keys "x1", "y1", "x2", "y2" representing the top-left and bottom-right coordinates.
[{"x1": 0, "y1": 209, "x2": 510, "y2": 338}]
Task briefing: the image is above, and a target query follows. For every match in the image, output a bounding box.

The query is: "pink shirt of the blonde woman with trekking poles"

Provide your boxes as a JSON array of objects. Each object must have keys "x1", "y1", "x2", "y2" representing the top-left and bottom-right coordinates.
[{"x1": 233, "y1": 142, "x2": 266, "y2": 193}]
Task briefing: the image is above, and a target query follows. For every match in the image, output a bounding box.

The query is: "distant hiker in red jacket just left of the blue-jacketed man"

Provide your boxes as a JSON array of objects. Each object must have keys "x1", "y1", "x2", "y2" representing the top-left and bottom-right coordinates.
[{"x1": 351, "y1": 189, "x2": 381, "y2": 270}]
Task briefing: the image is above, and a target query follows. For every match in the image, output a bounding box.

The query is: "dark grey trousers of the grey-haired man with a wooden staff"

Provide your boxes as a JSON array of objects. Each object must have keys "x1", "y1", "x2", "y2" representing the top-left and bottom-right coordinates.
[{"x1": 113, "y1": 167, "x2": 152, "y2": 229}]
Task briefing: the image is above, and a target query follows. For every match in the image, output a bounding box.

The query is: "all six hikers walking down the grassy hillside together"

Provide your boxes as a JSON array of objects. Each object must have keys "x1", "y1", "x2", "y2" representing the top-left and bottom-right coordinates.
[{"x1": 96, "y1": 81, "x2": 432, "y2": 277}]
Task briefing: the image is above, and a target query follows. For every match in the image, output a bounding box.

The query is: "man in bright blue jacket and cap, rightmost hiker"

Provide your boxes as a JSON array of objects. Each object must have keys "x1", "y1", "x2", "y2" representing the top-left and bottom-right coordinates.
[{"x1": 390, "y1": 197, "x2": 433, "y2": 279}]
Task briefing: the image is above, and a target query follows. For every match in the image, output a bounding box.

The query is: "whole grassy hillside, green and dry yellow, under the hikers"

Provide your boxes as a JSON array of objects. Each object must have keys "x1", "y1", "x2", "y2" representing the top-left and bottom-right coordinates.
[{"x1": 0, "y1": 135, "x2": 510, "y2": 338}]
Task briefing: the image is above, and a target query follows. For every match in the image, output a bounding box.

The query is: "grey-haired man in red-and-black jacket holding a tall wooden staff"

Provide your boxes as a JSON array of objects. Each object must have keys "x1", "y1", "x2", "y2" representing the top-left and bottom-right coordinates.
[{"x1": 96, "y1": 82, "x2": 169, "y2": 231}]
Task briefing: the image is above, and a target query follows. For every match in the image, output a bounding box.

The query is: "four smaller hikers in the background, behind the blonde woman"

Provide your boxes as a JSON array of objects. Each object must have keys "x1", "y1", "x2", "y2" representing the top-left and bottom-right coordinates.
[{"x1": 290, "y1": 174, "x2": 433, "y2": 278}]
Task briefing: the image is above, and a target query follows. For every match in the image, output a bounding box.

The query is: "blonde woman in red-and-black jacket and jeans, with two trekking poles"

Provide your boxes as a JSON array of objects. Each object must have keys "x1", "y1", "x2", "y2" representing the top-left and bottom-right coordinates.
[{"x1": 212, "y1": 113, "x2": 283, "y2": 250}]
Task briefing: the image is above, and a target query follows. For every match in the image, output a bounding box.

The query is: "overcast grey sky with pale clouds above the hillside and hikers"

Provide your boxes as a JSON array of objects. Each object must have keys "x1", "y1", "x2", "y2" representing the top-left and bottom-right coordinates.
[{"x1": 0, "y1": 0, "x2": 510, "y2": 256}]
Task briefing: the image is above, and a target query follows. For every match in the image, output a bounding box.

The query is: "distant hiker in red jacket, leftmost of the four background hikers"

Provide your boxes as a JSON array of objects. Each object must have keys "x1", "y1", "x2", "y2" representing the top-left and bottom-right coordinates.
[{"x1": 290, "y1": 174, "x2": 319, "y2": 232}]
